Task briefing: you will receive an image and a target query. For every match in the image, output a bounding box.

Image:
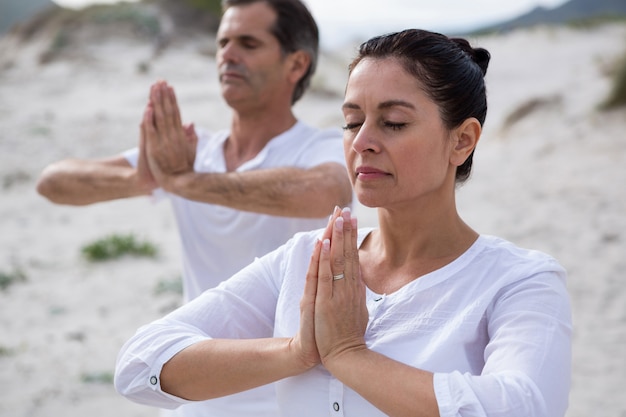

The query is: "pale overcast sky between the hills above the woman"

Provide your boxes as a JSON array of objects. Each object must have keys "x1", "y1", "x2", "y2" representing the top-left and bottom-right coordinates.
[{"x1": 54, "y1": 0, "x2": 567, "y2": 46}]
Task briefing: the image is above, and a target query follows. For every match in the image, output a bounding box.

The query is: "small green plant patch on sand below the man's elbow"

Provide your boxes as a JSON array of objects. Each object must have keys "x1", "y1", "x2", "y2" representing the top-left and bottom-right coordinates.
[{"x1": 81, "y1": 234, "x2": 158, "y2": 262}]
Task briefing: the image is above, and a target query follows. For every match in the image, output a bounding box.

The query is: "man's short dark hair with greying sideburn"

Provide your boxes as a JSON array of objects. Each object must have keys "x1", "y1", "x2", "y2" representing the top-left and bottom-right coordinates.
[{"x1": 222, "y1": 0, "x2": 319, "y2": 104}]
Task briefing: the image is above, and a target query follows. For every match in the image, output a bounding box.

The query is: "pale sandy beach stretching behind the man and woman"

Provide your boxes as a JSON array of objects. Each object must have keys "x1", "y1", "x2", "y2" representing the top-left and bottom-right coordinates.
[{"x1": 0, "y1": 18, "x2": 626, "y2": 417}]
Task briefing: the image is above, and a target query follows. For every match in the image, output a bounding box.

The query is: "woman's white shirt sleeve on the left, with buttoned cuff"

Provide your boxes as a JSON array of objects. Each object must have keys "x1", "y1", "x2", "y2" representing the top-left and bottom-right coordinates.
[{"x1": 114, "y1": 242, "x2": 284, "y2": 409}]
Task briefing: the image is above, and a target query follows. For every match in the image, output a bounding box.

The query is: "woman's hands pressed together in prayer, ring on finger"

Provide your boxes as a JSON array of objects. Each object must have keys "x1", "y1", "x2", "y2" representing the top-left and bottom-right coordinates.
[{"x1": 294, "y1": 208, "x2": 368, "y2": 368}]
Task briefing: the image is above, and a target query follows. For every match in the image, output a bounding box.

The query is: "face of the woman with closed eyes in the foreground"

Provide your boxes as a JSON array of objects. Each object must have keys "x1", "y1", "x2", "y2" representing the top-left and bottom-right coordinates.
[{"x1": 342, "y1": 58, "x2": 456, "y2": 208}]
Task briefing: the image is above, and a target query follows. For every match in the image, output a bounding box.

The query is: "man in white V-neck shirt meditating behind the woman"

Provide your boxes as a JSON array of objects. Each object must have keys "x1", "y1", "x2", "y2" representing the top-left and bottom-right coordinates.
[{"x1": 37, "y1": 0, "x2": 352, "y2": 417}]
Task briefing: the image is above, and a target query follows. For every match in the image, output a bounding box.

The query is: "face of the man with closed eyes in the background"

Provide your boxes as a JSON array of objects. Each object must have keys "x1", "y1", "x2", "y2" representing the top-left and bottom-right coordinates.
[{"x1": 217, "y1": 2, "x2": 292, "y2": 109}]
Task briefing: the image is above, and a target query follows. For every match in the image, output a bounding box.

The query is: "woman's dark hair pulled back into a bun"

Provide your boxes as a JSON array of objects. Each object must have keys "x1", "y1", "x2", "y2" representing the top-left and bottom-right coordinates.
[{"x1": 349, "y1": 29, "x2": 491, "y2": 183}]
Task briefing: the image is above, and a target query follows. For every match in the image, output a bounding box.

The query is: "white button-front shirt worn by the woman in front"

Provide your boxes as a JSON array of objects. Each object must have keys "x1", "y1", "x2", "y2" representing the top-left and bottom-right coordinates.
[{"x1": 115, "y1": 230, "x2": 572, "y2": 417}]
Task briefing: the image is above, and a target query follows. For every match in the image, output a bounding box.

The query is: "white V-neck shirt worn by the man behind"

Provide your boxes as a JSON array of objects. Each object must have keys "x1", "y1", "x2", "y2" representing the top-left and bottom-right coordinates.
[{"x1": 124, "y1": 121, "x2": 345, "y2": 417}]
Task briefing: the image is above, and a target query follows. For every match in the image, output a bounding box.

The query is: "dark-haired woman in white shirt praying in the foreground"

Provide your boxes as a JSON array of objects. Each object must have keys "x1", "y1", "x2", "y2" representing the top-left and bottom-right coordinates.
[{"x1": 116, "y1": 30, "x2": 571, "y2": 417}]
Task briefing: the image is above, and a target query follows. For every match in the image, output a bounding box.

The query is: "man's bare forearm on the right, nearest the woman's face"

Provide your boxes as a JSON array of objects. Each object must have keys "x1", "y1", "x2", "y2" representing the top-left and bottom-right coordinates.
[{"x1": 163, "y1": 163, "x2": 352, "y2": 218}]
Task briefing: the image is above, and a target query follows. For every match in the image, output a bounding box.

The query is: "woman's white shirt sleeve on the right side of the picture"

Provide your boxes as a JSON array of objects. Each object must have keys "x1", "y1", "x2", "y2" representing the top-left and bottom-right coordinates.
[{"x1": 434, "y1": 272, "x2": 572, "y2": 417}]
